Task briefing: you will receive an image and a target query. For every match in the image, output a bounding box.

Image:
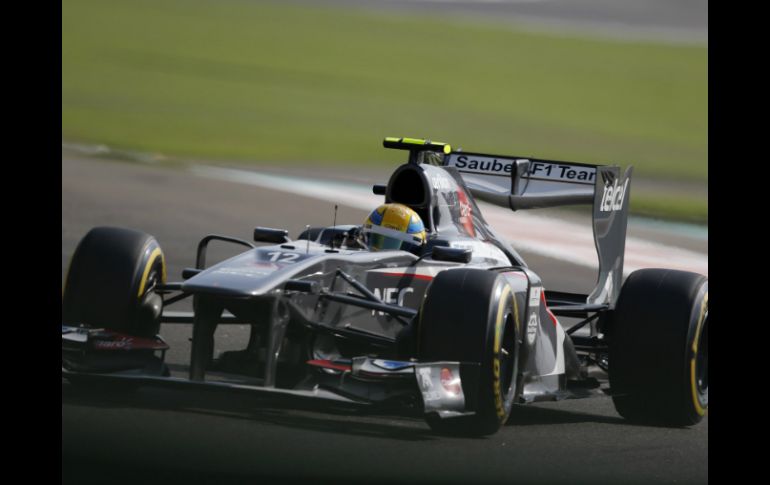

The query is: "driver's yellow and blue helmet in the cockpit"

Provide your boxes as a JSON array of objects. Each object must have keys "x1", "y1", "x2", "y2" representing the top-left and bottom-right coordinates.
[{"x1": 362, "y1": 203, "x2": 426, "y2": 252}]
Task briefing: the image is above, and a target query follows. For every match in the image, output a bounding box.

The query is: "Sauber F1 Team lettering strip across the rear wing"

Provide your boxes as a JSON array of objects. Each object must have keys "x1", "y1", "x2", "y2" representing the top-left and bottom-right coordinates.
[{"x1": 447, "y1": 154, "x2": 596, "y2": 185}]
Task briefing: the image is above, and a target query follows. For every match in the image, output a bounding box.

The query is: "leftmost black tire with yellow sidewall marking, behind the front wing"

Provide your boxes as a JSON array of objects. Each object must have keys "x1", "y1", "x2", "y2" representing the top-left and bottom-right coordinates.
[{"x1": 62, "y1": 227, "x2": 166, "y2": 337}]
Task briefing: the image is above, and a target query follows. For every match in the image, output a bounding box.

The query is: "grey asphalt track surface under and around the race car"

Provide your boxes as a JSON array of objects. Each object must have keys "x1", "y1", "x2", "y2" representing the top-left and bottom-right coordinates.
[{"x1": 62, "y1": 151, "x2": 709, "y2": 483}]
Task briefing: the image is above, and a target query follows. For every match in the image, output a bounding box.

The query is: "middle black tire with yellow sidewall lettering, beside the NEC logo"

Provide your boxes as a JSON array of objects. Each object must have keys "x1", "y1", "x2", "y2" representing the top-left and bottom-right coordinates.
[{"x1": 417, "y1": 269, "x2": 520, "y2": 436}]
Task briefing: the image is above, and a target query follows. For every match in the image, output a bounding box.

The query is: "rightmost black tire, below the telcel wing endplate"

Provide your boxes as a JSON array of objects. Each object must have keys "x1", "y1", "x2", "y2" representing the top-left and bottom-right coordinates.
[{"x1": 609, "y1": 269, "x2": 708, "y2": 426}]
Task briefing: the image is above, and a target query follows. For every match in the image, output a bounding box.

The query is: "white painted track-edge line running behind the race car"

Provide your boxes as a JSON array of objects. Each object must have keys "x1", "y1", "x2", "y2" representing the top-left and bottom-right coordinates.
[{"x1": 191, "y1": 165, "x2": 708, "y2": 276}]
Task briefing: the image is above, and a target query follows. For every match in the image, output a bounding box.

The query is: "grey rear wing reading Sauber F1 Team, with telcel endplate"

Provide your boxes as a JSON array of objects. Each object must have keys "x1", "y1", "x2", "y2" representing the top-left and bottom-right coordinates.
[{"x1": 383, "y1": 138, "x2": 633, "y2": 308}]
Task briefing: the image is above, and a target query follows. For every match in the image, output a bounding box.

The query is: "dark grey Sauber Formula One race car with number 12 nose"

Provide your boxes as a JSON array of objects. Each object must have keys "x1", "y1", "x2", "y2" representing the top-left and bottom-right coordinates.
[{"x1": 62, "y1": 138, "x2": 708, "y2": 435}]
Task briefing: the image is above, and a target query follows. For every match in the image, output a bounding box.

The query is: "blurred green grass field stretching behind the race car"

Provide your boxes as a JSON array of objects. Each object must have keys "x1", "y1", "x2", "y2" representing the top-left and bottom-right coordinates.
[{"x1": 62, "y1": 0, "x2": 708, "y2": 222}]
